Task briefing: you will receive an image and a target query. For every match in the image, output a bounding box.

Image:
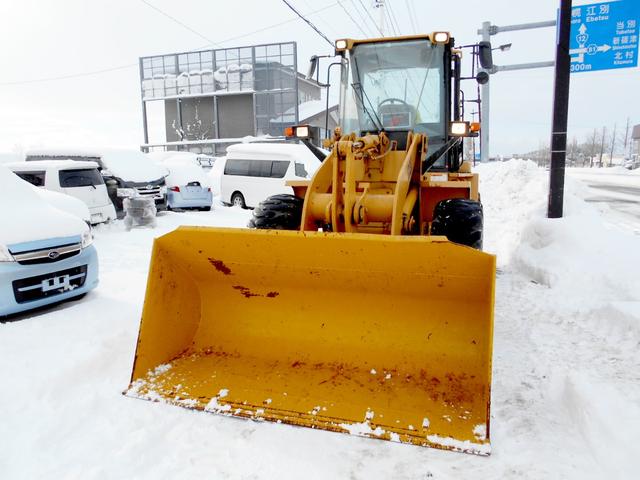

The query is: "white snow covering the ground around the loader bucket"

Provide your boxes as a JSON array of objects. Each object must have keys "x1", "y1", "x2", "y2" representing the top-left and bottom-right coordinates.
[{"x1": 0, "y1": 160, "x2": 640, "y2": 479}]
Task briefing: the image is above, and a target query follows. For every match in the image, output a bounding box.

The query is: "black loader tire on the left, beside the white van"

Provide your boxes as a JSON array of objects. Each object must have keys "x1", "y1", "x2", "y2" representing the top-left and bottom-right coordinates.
[{"x1": 249, "y1": 194, "x2": 304, "y2": 230}]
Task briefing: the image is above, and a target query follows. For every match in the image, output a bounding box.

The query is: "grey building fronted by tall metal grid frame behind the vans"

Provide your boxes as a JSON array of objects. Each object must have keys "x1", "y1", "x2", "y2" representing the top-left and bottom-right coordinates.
[{"x1": 140, "y1": 42, "x2": 336, "y2": 155}]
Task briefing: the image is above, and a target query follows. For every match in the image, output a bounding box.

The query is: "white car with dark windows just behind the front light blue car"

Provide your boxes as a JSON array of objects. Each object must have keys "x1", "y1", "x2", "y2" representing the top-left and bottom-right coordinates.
[{"x1": 7, "y1": 160, "x2": 116, "y2": 225}]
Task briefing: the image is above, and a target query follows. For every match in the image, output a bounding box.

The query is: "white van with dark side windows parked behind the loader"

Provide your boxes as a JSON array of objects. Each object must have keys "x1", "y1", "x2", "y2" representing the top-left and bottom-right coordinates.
[{"x1": 220, "y1": 143, "x2": 320, "y2": 208}]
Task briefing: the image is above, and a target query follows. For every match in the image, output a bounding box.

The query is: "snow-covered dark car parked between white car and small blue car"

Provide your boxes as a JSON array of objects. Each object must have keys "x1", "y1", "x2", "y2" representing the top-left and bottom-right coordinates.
[{"x1": 25, "y1": 149, "x2": 169, "y2": 212}]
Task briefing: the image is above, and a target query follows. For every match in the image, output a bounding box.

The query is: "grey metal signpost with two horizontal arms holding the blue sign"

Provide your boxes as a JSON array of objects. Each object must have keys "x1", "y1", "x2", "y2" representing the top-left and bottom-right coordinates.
[{"x1": 478, "y1": 20, "x2": 556, "y2": 162}]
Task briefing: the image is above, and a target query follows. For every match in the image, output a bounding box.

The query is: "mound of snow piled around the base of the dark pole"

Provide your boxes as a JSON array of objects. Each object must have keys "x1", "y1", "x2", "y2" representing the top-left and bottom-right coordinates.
[{"x1": 513, "y1": 167, "x2": 640, "y2": 307}]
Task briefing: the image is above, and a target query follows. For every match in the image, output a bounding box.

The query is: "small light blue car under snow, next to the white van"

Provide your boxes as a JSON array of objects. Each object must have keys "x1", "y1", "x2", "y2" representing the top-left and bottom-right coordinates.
[{"x1": 164, "y1": 159, "x2": 213, "y2": 210}]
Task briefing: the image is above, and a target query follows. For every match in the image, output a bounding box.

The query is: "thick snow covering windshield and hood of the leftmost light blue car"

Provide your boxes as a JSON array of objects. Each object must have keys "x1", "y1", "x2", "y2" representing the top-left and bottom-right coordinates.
[{"x1": 0, "y1": 165, "x2": 89, "y2": 245}]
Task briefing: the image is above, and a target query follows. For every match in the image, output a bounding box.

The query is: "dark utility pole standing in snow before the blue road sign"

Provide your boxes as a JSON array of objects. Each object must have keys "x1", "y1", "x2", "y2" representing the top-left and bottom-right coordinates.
[{"x1": 547, "y1": 0, "x2": 571, "y2": 218}]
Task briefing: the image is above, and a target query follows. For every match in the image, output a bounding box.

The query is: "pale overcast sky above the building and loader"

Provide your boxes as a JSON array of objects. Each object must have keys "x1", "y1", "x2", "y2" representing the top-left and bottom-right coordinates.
[{"x1": 0, "y1": 0, "x2": 640, "y2": 155}]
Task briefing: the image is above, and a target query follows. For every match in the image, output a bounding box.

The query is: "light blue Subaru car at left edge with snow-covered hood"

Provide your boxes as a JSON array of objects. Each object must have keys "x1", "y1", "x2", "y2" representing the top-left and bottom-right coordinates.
[{"x1": 0, "y1": 165, "x2": 98, "y2": 316}]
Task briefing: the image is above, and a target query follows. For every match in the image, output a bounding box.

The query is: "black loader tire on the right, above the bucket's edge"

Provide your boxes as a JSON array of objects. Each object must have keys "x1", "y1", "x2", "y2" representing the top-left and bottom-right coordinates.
[{"x1": 431, "y1": 198, "x2": 484, "y2": 250}]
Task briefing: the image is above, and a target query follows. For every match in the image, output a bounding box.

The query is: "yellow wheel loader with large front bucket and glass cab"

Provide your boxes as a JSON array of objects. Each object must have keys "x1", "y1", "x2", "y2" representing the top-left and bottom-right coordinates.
[{"x1": 127, "y1": 32, "x2": 495, "y2": 454}]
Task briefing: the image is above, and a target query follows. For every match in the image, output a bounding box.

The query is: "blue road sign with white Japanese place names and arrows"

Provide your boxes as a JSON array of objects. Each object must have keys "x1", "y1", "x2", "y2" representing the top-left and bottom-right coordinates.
[{"x1": 569, "y1": 0, "x2": 640, "y2": 73}]
